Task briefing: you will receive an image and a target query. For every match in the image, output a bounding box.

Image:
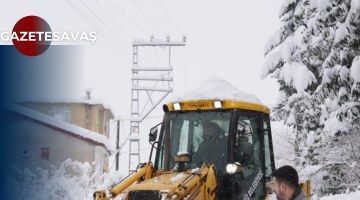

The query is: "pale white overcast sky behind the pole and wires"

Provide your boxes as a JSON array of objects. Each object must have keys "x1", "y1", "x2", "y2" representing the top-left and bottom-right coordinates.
[{"x1": 0, "y1": 0, "x2": 282, "y2": 173}]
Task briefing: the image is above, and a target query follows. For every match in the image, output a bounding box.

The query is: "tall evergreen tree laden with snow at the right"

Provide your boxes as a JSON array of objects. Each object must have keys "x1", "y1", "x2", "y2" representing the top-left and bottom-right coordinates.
[{"x1": 261, "y1": 0, "x2": 360, "y2": 195}]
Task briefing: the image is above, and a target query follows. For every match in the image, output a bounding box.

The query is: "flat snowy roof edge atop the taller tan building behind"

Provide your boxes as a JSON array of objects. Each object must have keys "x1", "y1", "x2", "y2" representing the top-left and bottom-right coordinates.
[{"x1": 14, "y1": 97, "x2": 115, "y2": 116}]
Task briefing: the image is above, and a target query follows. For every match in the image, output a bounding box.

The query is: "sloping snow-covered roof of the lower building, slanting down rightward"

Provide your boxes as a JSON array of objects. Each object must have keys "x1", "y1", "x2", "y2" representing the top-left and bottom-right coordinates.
[{"x1": 4, "y1": 103, "x2": 115, "y2": 152}]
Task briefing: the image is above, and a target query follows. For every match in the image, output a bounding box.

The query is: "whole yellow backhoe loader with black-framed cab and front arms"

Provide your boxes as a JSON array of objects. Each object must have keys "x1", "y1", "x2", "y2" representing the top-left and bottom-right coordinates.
[{"x1": 94, "y1": 100, "x2": 310, "y2": 200}]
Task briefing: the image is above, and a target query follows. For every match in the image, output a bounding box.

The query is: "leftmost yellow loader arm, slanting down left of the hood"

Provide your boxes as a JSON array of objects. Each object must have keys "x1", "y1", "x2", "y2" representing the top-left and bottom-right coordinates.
[{"x1": 94, "y1": 162, "x2": 153, "y2": 200}]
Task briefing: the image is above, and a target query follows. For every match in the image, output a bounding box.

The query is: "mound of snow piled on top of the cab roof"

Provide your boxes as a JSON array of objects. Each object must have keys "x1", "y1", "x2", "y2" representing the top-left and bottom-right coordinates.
[{"x1": 171, "y1": 76, "x2": 260, "y2": 104}]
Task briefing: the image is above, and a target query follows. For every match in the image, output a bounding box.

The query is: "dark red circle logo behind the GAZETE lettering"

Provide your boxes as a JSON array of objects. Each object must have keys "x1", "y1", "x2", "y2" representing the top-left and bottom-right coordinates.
[{"x1": 12, "y1": 16, "x2": 52, "y2": 56}]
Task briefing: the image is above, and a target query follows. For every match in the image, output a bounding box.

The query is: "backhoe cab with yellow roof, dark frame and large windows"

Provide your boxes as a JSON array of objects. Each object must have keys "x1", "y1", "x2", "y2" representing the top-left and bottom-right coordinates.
[{"x1": 154, "y1": 100, "x2": 275, "y2": 200}]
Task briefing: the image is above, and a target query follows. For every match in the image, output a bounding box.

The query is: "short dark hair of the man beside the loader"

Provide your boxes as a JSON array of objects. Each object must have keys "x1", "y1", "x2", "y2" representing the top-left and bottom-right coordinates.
[{"x1": 271, "y1": 165, "x2": 299, "y2": 189}]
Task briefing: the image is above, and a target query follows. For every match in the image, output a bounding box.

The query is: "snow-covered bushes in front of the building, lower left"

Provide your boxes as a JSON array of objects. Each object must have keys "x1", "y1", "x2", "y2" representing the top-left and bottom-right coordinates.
[{"x1": 1, "y1": 159, "x2": 121, "y2": 200}]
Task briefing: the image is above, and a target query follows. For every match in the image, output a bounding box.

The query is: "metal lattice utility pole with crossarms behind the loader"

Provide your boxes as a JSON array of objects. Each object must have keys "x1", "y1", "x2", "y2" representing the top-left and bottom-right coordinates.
[{"x1": 129, "y1": 35, "x2": 186, "y2": 174}]
